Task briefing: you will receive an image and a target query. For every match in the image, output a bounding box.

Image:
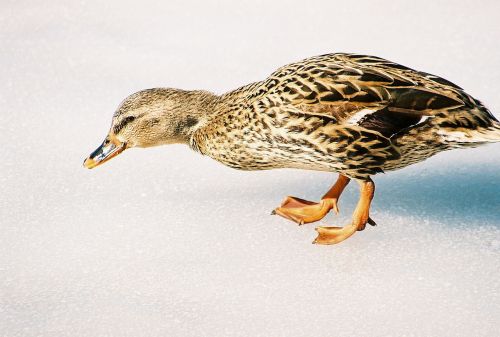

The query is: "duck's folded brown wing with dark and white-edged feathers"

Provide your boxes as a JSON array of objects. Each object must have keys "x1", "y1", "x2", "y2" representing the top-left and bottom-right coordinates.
[{"x1": 254, "y1": 54, "x2": 480, "y2": 138}]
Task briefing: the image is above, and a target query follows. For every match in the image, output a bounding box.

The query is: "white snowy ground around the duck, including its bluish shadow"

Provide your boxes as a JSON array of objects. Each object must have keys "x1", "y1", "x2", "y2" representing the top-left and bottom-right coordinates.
[{"x1": 0, "y1": 0, "x2": 500, "y2": 337}]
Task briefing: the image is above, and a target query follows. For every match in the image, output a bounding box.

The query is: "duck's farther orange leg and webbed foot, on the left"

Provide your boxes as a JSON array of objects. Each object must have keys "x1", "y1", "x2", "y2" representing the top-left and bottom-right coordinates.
[{"x1": 272, "y1": 174, "x2": 350, "y2": 225}]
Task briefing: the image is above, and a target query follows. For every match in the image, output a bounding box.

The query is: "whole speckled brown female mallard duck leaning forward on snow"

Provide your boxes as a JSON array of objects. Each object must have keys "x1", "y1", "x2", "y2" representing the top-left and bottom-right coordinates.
[{"x1": 84, "y1": 54, "x2": 500, "y2": 244}]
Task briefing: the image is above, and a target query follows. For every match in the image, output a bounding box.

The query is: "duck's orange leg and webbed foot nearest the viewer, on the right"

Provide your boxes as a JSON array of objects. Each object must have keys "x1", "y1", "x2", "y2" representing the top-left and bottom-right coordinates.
[{"x1": 313, "y1": 178, "x2": 375, "y2": 245}]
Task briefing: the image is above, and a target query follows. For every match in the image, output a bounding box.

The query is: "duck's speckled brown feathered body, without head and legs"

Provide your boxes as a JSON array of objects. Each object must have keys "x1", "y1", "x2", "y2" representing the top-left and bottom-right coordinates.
[{"x1": 190, "y1": 54, "x2": 500, "y2": 179}]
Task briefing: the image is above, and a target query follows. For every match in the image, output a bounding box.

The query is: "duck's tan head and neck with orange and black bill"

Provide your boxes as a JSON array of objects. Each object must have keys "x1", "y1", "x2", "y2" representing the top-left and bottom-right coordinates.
[{"x1": 83, "y1": 88, "x2": 215, "y2": 169}]
